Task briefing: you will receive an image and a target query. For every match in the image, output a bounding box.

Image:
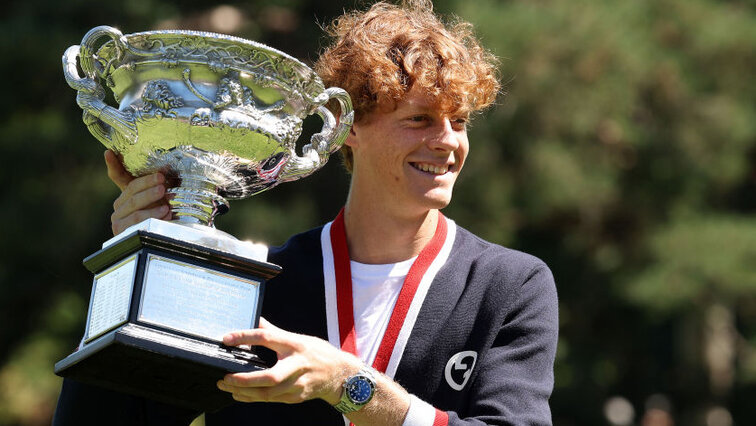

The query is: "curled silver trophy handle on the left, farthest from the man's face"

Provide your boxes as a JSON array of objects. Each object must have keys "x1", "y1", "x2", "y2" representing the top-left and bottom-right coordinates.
[{"x1": 63, "y1": 25, "x2": 137, "y2": 151}]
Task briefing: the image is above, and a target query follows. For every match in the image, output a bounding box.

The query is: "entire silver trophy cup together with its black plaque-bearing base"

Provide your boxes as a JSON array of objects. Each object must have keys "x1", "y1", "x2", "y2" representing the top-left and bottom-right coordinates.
[{"x1": 55, "y1": 26, "x2": 354, "y2": 411}]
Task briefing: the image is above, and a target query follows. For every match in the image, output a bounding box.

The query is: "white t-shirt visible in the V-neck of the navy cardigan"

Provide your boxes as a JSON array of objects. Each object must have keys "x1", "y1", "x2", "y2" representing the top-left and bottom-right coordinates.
[{"x1": 350, "y1": 257, "x2": 416, "y2": 365}]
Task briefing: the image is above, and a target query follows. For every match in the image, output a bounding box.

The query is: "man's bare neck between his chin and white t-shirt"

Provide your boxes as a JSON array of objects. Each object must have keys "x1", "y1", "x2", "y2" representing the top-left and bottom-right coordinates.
[{"x1": 344, "y1": 197, "x2": 439, "y2": 264}]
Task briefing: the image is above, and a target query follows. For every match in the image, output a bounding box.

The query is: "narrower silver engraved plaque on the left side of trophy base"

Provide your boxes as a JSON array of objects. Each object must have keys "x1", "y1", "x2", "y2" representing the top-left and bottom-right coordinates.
[{"x1": 84, "y1": 255, "x2": 137, "y2": 342}]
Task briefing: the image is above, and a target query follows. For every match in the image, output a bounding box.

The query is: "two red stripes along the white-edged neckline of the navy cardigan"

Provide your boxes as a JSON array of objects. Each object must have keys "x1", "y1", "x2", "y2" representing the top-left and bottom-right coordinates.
[{"x1": 331, "y1": 208, "x2": 447, "y2": 373}]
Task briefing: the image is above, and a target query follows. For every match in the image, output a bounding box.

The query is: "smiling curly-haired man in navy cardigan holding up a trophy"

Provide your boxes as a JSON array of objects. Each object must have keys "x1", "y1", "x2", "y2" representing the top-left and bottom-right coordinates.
[{"x1": 56, "y1": 1, "x2": 557, "y2": 425}]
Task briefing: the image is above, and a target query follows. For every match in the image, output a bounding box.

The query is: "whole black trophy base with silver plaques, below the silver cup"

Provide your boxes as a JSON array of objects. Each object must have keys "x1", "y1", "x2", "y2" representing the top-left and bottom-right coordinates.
[{"x1": 55, "y1": 226, "x2": 281, "y2": 411}]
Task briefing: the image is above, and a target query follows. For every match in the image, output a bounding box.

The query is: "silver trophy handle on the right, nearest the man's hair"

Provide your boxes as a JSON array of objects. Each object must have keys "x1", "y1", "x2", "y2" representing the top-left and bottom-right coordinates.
[{"x1": 278, "y1": 87, "x2": 354, "y2": 182}]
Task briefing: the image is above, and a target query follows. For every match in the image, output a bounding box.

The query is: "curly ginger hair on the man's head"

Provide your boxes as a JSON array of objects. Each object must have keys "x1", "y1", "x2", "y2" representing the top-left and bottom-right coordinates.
[{"x1": 315, "y1": 0, "x2": 500, "y2": 171}]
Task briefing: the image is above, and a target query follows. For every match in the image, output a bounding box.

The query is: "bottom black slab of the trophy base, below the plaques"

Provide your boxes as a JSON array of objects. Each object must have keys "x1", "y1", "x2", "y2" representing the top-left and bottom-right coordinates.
[{"x1": 55, "y1": 324, "x2": 268, "y2": 411}]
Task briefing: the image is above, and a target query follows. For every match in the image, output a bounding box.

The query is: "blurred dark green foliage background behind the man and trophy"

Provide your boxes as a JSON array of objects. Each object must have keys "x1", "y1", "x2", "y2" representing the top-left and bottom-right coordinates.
[{"x1": 0, "y1": 0, "x2": 756, "y2": 426}]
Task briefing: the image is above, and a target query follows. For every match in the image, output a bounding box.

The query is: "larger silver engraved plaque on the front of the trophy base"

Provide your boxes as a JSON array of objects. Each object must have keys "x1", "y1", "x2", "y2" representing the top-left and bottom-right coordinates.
[{"x1": 139, "y1": 254, "x2": 260, "y2": 341}]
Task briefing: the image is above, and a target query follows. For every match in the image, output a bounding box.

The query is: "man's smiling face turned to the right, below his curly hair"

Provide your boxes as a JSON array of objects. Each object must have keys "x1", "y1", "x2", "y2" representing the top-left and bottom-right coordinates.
[{"x1": 346, "y1": 88, "x2": 469, "y2": 220}]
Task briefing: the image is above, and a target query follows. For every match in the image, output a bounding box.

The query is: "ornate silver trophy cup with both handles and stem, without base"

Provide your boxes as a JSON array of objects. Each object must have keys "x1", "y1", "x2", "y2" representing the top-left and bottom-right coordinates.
[{"x1": 63, "y1": 26, "x2": 354, "y2": 225}]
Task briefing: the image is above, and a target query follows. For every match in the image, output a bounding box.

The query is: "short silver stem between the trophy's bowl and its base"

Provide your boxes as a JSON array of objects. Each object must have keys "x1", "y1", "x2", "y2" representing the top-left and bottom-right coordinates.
[{"x1": 167, "y1": 176, "x2": 228, "y2": 227}]
